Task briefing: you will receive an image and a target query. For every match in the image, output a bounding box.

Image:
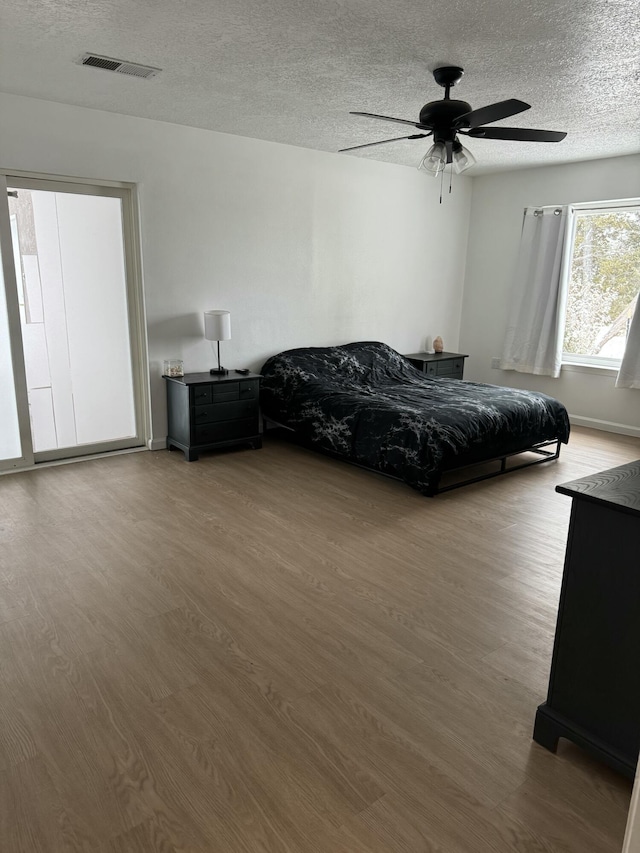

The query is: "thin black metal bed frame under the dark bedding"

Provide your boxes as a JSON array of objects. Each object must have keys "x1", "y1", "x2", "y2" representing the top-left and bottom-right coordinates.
[{"x1": 263, "y1": 418, "x2": 561, "y2": 498}]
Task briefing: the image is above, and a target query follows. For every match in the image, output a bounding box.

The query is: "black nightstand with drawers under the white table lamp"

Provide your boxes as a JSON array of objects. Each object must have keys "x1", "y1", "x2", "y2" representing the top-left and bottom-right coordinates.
[{"x1": 164, "y1": 371, "x2": 262, "y2": 462}]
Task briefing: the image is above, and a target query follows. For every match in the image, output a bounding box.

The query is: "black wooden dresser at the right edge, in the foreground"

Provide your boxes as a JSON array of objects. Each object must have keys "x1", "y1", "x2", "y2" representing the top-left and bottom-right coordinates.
[{"x1": 533, "y1": 460, "x2": 640, "y2": 778}]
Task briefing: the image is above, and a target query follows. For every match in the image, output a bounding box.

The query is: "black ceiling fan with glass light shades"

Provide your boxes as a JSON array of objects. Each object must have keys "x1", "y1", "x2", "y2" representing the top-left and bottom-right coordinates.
[{"x1": 340, "y1": 65, "x2": 567, "y2": 177}]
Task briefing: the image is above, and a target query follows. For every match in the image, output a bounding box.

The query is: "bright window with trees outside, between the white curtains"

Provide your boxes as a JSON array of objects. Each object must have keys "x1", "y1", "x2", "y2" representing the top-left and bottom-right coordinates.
[{"x1": 562, "y1": 206, "x2": 640, "y2": 367}]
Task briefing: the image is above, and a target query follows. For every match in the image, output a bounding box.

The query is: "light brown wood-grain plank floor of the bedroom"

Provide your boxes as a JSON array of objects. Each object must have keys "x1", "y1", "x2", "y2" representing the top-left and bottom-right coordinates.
[{"x1": 0, "y1": 429, "x2": 640, "y2": 853}]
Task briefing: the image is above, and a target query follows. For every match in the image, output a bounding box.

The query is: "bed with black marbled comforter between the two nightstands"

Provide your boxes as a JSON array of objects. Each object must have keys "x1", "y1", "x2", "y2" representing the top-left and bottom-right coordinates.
[{"x1": 260, "y1": 341, "x2": 569, "y2": 495}]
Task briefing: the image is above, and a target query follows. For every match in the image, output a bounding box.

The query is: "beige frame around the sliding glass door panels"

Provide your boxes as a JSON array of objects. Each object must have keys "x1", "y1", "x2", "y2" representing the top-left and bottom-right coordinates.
[{"x1": 0, "y1": 169, "x2": 151, "y2": 462}]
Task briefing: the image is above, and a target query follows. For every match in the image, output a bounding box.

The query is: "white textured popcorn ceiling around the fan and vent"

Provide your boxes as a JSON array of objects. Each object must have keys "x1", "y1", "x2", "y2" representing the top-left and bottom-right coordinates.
[{"x1": 0, "y1": 0, "x2": 640, "y2": 174}]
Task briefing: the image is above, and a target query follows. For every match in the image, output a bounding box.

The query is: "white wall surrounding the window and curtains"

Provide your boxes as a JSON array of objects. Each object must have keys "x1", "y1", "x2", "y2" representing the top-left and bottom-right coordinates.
[{"x1": 460, "y1": 156, "x2": 640, "y2": 434}]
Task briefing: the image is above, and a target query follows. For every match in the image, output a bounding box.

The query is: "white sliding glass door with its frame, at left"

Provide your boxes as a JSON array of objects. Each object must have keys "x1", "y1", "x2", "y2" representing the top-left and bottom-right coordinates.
[{"x1": 0, "y1": 175, "x2": 148, "y2": 468}]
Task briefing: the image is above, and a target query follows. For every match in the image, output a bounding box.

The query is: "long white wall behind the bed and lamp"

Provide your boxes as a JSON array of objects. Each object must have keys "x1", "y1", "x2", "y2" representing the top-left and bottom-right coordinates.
[{"x1": 0, "y1": 92, "x2": 471, "y2": 439}]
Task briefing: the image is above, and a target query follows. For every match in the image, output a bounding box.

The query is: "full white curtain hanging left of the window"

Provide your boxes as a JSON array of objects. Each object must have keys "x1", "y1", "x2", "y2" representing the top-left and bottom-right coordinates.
[{"x1": 500, "y1": 207, "x2": 576, "y2": 376}]
